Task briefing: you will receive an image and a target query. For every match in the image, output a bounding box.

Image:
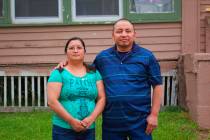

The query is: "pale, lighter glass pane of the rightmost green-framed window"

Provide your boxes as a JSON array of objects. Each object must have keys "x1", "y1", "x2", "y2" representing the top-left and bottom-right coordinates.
[{"x1": 129, "y1": 0, "x2": 174, "y2": 14}]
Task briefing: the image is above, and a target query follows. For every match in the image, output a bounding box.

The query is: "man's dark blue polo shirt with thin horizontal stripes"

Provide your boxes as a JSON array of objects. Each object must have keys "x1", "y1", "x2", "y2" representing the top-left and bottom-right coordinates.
[{"x1": 94, "y1": 43, "x2": 162, "y2": 131}]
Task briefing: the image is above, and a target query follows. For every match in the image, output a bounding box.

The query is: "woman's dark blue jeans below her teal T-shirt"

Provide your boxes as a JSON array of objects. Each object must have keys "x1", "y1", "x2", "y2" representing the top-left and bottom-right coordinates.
[{"x1": 52, "y1": 125, "x2": 95, "y2": 140}]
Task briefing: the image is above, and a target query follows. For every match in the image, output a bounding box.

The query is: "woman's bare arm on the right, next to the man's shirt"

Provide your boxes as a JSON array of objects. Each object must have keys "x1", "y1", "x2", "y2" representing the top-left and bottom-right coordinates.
[{"x1": 82, "y1": 80, "x2": 106, "y2": 128}]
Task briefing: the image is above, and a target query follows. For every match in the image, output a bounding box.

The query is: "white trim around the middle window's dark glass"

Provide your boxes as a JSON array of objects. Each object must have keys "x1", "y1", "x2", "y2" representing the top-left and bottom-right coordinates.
[{"x1": 71, "y1": 0, "x2": 123, "y2": 22}]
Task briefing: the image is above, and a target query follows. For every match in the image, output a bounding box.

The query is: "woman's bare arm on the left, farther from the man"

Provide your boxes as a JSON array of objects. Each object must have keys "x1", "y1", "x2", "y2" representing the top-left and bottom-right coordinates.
[{"x1": 47, "y1": 82, "x2": 85, "y2": 132}]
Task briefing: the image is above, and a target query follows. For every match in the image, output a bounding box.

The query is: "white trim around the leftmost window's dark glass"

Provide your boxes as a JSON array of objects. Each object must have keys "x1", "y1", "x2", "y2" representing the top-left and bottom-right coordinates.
[{"x1": 10, "y1": 0, "x2": 63, "y2": 24}]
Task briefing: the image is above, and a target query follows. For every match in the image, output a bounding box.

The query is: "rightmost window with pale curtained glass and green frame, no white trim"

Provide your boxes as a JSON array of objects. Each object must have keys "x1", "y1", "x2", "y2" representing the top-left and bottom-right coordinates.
[{"x1": 127, "y1": 0, "x2": 181, "y2": 22}]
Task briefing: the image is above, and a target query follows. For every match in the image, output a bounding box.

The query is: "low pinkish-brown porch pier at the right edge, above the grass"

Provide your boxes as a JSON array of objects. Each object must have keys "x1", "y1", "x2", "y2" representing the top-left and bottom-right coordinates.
[{"x1": 184, "y1": 53, "x2": 210, "y2": 129}]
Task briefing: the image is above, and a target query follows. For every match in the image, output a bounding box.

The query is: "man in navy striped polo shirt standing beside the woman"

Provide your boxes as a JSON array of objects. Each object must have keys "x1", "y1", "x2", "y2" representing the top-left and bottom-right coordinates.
[{"x1": 58, "y1": 19, "x2": 162, "y2": 140}]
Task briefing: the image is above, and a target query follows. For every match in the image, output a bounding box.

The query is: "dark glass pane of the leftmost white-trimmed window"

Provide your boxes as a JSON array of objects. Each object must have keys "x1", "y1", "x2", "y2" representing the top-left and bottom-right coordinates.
[{"x1": 15, "y1": 0, "x2": 58, "y2": 17}]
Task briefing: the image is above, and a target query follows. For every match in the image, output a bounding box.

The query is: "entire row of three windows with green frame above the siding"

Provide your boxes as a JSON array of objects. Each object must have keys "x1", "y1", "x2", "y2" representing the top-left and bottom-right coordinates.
[{"x1": 0, "y1": 0, "x2": 181, "y2": 26}]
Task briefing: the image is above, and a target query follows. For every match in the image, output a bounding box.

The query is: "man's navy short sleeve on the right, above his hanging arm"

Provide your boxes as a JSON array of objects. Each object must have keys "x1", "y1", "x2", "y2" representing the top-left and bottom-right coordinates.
[{"x1": 148, "y1": 55, "x2": 162, "y2": 86}]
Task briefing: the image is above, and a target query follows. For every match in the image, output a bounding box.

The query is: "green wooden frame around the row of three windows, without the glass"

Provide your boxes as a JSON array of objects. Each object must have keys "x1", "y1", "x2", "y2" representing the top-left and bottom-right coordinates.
[{"x1": 0, "y1": 0, "x2": 182, "y2": 27}]
